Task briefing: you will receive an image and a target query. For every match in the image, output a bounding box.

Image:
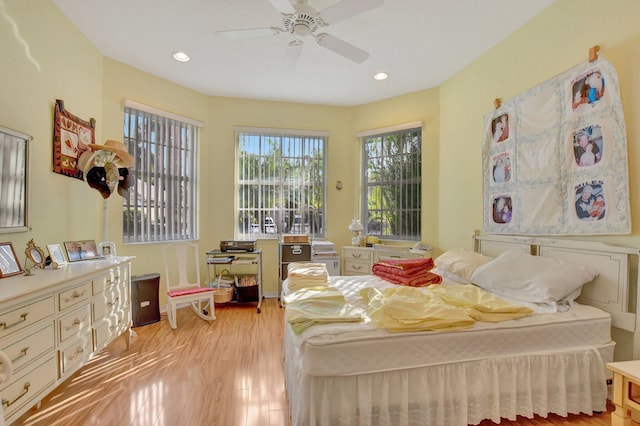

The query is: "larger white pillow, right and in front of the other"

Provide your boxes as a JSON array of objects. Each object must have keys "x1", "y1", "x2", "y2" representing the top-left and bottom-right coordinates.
[{"x1": 471, "y1": 251, "x2": 598, "y2": 303}]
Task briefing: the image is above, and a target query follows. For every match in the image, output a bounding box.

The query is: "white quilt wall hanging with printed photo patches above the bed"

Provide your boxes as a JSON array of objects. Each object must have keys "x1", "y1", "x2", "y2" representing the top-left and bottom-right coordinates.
[{"x1": 482, "y1": 58, "x2": 631, "y2": 235}]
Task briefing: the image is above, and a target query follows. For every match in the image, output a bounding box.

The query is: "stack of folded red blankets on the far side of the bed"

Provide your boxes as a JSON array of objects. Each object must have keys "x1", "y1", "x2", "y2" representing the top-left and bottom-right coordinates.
[{"x1": 372, "y1": 258, "x2": 442, "y2": 287}]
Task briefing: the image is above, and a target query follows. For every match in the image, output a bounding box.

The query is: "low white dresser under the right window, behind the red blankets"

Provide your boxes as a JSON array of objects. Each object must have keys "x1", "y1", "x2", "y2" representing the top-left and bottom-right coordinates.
[{"x1": 342, "y1": 244, "x2": 431, "y2": 275}]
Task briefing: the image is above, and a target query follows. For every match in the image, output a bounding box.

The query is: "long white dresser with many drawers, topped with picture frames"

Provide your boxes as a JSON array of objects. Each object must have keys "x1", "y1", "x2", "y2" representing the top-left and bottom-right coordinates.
[{"x1": 0, "y1": 257, "x2": 132, "y2": 424}]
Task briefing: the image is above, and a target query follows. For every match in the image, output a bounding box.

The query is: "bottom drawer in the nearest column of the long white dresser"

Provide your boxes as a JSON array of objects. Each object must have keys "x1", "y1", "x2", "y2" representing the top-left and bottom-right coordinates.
[{"x1": 0, "y1": 357, "x2": 58, "y2": 419}]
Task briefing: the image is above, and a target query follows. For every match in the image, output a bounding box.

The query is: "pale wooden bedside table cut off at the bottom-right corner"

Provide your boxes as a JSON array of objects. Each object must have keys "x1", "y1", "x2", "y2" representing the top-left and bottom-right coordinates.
[{"x1": 607, "y1": 361, "x2": 640, "y2": 426}]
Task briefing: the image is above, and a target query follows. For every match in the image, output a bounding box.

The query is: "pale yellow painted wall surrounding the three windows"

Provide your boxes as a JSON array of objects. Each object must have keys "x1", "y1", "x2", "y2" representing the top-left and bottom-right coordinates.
[{"x1": 0, "y1": 0, "x2": 640, "y2": 303}]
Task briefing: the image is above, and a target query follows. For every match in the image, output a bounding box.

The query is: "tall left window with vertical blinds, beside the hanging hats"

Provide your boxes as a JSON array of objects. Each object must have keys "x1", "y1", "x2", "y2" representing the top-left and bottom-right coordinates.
[{"x1": 122, "y1": 101, "x2": 201, "y2": 243}]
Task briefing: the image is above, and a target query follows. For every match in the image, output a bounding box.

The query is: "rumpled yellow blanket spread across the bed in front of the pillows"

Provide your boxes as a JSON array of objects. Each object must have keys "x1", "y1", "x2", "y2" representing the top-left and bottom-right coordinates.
[{"x1": 360, "y1": 284, "x2": 533, "y2": 332}]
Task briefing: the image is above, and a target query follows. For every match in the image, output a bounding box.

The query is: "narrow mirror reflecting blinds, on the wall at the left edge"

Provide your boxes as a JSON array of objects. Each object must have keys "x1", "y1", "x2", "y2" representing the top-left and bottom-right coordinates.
[{"x1": 0, "y1": 127, "x2": 31, "y2": 233}]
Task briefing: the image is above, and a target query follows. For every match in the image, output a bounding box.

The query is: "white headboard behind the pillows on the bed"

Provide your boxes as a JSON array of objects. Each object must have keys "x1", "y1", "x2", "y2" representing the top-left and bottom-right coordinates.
[{"x1": 474, "y1": 234, "x2": 640, "y2": 359}]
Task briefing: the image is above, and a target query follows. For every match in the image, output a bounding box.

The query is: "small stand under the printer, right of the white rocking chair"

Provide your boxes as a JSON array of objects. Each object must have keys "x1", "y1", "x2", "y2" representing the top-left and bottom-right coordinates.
[{"x1": 206, "y1": 249, "x2": 262, "y2": 313}]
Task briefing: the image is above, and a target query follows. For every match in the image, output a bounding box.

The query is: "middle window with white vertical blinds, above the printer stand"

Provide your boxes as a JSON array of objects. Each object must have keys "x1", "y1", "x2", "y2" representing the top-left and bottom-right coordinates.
[{"x1": 236, "y1": 128, "x2": 328, "y2": 238}]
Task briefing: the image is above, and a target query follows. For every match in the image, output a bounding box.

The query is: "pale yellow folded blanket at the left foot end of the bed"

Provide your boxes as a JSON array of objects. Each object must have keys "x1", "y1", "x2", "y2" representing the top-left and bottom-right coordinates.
[{"x1": 284, "y1": 286, "x2": 364, "y2": 334}]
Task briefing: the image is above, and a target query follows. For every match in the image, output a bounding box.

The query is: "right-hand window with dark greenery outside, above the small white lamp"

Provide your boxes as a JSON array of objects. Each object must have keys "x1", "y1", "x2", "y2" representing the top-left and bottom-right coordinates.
[{"x1": 358, "y1": 123, "x2": 422, "y2": 241}]
